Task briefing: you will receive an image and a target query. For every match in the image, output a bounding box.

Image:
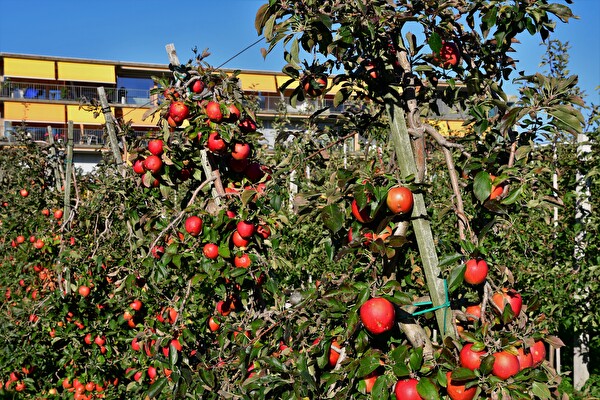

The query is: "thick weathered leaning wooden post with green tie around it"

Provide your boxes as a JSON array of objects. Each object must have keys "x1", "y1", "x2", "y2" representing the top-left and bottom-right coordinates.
[{"x1": 386, "y1": 98, "x2": 455, "y2": 340}]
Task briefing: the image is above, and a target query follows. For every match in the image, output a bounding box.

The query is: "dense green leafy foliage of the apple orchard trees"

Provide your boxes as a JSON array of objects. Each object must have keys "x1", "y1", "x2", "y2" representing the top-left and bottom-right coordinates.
[{"x1": 0, "y1": 0, "x2": 597, "y2": 399}]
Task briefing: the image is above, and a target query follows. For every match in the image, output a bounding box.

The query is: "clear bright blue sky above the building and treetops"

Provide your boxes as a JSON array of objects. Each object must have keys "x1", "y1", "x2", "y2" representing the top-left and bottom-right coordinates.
[{"x1": 0, "y1": 0, "x2": 600, "y2": 104}]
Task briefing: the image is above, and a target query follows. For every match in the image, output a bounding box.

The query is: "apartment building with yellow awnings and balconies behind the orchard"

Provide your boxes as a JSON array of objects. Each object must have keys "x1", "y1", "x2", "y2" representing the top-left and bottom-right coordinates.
[{"x1": 0, "y1": 53, "x2": 464, "y2": 171}]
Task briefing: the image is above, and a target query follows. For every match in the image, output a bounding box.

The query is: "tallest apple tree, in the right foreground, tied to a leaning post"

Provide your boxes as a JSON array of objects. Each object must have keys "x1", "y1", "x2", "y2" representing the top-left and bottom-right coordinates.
[{"x1": 256, "y1": 0, "x2": 583, "y2": 398}]
